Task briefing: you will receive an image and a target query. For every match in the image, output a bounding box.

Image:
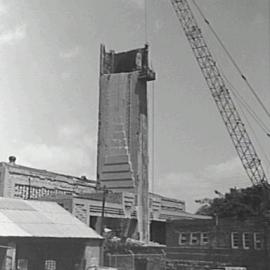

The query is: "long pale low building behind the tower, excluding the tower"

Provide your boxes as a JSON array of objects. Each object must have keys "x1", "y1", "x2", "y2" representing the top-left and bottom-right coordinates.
[{"x1": 0, "y1": 157, "x2": 205, "y2": 244}]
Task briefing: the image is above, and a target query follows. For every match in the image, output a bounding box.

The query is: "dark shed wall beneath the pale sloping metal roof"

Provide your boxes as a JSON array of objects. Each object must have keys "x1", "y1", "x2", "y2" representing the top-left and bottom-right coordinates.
[{"x1": 16, "y1": 238, "x2": 102, "y2": 270}]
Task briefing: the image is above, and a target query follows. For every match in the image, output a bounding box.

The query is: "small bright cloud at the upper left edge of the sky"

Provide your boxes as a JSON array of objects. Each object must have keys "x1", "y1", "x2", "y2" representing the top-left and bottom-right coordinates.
[{"x1": 0, "y1": 24, "x2": 26, "y2": 44}]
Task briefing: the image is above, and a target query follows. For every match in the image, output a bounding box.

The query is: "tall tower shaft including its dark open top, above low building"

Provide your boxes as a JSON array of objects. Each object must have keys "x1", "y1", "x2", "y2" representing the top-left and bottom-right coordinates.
[{"x1": 97, "y1": 48, "x2": 152, "y2": 191}]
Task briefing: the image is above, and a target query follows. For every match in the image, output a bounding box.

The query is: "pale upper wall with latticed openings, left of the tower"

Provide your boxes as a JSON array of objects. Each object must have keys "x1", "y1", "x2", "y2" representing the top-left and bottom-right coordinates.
[{"x1": 0, "y1": 162, "x2": 96, "y2": 199}]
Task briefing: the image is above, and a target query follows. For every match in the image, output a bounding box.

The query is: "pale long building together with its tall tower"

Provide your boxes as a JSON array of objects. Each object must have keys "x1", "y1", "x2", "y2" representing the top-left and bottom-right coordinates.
[{"x1": 0, "y1": 45, "x2": 206, "y2": 251}]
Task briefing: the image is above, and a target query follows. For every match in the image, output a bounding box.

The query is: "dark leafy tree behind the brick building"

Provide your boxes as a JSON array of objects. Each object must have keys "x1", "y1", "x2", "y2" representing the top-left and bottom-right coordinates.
[{"x1": 196, "y1": 185, "x2": 270, "y2": 218}]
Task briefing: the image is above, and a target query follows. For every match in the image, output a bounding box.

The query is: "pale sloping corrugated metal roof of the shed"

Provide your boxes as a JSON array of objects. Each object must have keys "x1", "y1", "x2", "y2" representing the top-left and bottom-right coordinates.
[{"x1": 0, "y1": 198, "x2": 102, "y2": 239}]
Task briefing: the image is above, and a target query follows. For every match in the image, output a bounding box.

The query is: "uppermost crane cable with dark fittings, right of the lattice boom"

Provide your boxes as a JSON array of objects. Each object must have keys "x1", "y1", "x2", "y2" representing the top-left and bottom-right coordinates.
[{"x1": 191, "y1": 0, "x2": 270, "y2": 121}]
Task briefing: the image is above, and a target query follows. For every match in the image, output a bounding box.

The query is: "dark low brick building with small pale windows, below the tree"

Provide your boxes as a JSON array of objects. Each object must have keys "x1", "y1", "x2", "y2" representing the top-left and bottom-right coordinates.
[{"x1": 166, "y1": 218, "x2": 270, "y2": 270}]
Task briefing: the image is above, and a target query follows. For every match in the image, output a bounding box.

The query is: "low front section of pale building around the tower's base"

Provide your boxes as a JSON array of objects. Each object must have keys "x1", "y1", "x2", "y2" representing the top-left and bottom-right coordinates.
[{"x1": 44, "y1": 192, "x2": 208, "y2": 244}]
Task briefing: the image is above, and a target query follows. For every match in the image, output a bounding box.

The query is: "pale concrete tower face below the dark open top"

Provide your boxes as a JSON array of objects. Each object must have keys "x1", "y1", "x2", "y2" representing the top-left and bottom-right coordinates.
[{"x1": 98, "y1": 71, "x2": 147, "y2": 191}]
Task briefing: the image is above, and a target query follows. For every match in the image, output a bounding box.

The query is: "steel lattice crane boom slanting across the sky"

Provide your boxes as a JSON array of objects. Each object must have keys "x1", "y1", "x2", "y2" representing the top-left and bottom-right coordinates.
[{"x1": 171, "y1": 0, "x2": 268, "y2": 187}]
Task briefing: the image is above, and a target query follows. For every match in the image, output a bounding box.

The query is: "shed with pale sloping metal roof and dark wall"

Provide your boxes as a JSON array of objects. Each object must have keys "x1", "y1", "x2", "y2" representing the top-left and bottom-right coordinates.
[{"x1": 0, "y1": 198, "x2": 103, "y2": 270}]
